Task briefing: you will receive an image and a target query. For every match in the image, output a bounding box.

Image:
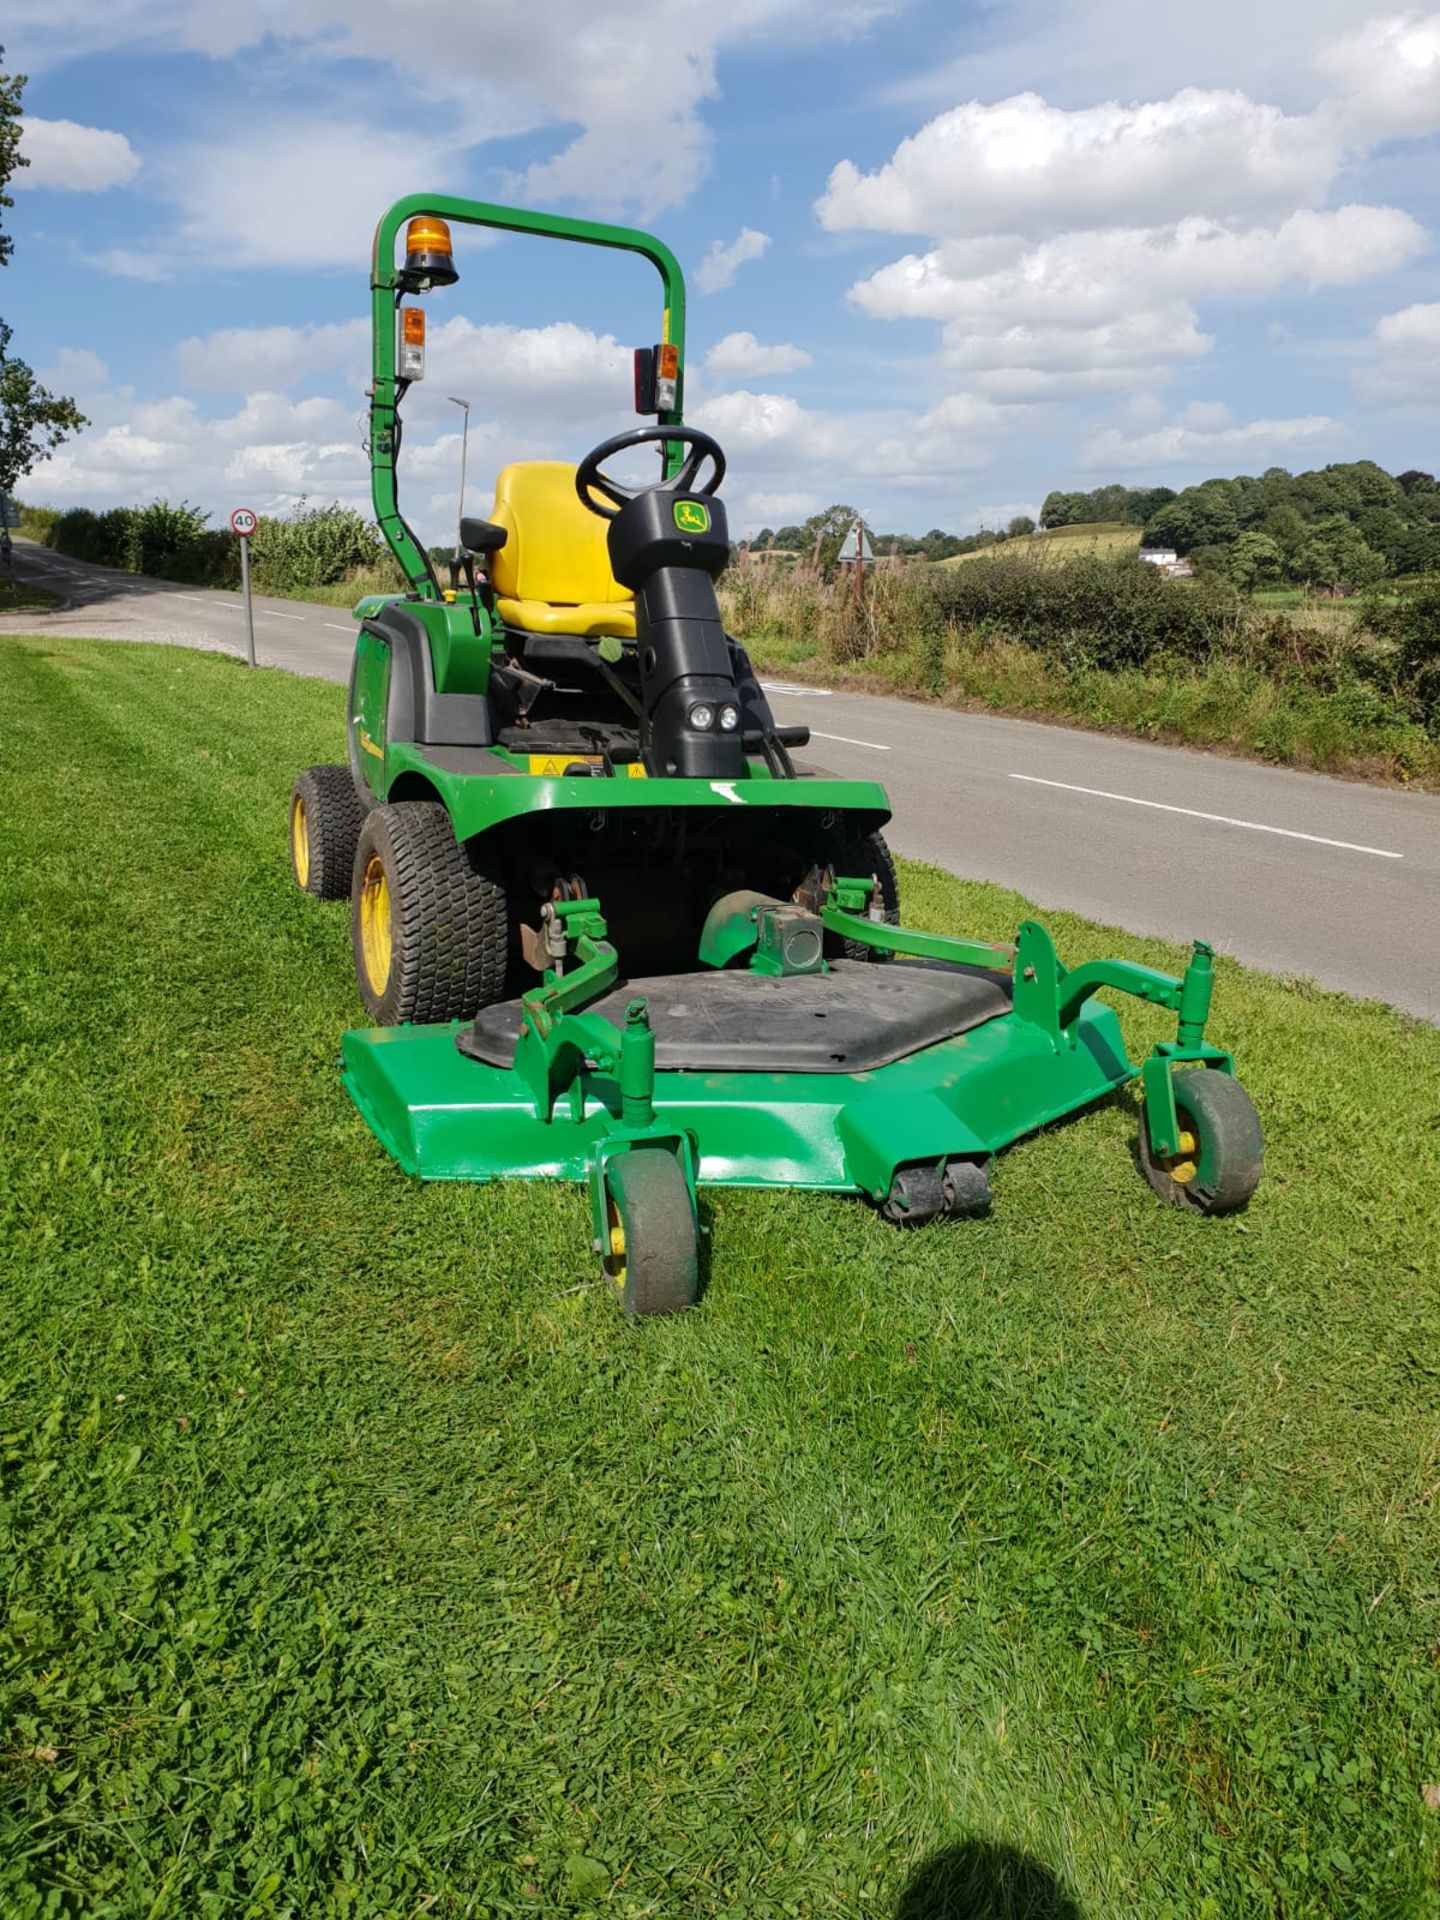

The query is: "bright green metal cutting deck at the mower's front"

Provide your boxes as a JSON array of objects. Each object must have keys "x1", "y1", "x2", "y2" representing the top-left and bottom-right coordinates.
[{"x1": 342, "y1": 964, "x2": 1137, "y2": 1198}]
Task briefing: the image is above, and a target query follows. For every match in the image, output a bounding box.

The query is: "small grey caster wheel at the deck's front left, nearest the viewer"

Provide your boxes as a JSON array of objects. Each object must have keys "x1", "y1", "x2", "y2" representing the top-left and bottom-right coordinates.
[{"x1": 601, "y1": 1146, "x2": 701, "y2": 1319}]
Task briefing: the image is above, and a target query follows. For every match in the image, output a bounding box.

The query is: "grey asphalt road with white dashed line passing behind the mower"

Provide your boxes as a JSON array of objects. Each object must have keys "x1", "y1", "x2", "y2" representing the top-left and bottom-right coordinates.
[{"x1": 11, "y1": 541, "x2": 1440, "y2": 1023}]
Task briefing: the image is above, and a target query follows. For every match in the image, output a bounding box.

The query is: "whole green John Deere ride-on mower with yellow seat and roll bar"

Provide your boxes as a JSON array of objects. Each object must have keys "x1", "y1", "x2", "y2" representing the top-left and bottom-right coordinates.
[{"x1": 290, "y1": 196, "x2": 1261, "y2": 1313}]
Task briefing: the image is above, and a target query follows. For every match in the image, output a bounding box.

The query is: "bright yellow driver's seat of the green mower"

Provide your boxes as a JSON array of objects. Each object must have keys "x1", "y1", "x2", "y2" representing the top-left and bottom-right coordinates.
[{"x1": 490, "y1": 461, "x2": 636, "y2": 639}]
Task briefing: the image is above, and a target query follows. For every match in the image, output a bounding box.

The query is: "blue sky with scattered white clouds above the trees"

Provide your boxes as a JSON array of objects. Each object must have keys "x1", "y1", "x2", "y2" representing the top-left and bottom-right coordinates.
[{"x1": 0, "y1": 0, "x2": 1440, "y2": 540}]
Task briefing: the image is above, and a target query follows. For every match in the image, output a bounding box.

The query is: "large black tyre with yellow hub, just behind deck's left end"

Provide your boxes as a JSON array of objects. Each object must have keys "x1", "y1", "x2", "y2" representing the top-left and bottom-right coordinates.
[{"x1": 346, "y1": 802, "x2": 509, "y2": 1027}]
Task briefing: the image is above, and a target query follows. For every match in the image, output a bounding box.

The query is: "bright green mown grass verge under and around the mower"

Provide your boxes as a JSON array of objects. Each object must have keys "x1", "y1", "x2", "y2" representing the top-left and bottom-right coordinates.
[{"x1": 0, "y1": 641, "x2": 1440, "y2": 1920}]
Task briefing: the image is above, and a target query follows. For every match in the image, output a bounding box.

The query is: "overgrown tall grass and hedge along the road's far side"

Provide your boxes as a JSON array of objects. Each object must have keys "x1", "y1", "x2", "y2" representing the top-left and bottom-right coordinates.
[{"x1": 722, "y1": 551, "x2": 1440, "y2": 785}]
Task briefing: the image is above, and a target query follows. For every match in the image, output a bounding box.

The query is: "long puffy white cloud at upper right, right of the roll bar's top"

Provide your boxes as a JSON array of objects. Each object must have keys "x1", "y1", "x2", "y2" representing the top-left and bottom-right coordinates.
[{"x1": 816, "y1": 88, "x2": 1338, "y2": 238}]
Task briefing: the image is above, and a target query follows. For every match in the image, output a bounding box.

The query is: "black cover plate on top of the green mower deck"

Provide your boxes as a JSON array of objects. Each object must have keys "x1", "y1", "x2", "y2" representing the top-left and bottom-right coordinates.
[{"x1": 457, "y1": 960, "x2": 1010, "y2": 1073}]
